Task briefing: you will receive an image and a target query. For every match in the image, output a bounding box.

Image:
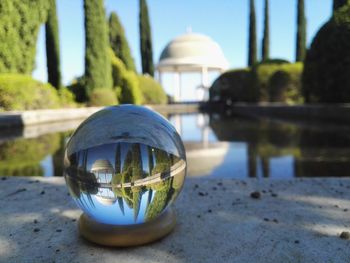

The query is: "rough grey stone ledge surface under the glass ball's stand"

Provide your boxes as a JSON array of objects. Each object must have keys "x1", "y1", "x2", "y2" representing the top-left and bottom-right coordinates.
[{"x1": 0, "y1": 177, "x2": 350, "y2": 263}]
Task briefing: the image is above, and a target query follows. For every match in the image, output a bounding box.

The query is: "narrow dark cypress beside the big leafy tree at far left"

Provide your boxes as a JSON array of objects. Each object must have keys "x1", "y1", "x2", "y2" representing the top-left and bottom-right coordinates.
[{"x1": 45, "y1": 0, "x2": 61, "y2": 89}]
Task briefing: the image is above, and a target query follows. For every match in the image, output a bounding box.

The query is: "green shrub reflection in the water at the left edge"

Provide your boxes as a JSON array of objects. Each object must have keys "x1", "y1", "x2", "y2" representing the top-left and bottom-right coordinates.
[{"x1": 0, "y1": 134, "x2": 60, "y2": 176}]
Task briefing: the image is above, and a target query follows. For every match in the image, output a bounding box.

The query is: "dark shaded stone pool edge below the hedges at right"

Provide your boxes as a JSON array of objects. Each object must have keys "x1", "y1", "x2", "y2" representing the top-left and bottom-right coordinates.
[{"x1": 228, "y1": 103, "x2": 350, "y2": 123}]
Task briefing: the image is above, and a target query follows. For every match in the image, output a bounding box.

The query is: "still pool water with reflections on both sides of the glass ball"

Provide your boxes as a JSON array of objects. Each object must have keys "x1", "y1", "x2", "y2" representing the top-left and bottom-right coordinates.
[{"x1": 0, "y1": 113, "x2": 350, "y2": 179}]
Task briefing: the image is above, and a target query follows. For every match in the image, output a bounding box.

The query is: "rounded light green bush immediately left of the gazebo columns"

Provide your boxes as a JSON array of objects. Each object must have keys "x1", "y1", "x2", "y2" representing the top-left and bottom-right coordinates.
[{"x1": 138, "y1": 75, "x2": 168, "y2": 104}]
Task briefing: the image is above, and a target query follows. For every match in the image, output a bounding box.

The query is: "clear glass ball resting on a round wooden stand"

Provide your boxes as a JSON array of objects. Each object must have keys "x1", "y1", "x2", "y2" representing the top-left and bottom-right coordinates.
[{"x1": 64, "y1": 105, "x2": 186, "y2": 225}]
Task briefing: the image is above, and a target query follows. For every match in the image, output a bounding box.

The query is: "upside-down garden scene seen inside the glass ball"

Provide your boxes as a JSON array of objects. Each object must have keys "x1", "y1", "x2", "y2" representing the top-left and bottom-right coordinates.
[{"x1": 65, "y1": 142, "x2": 186, "y2": 225}]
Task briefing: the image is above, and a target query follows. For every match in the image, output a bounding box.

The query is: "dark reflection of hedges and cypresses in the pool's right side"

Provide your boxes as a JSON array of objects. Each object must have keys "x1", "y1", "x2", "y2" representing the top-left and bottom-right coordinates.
[{"x1": 209, "y1": 116, "x2": 350, "y2": 178}]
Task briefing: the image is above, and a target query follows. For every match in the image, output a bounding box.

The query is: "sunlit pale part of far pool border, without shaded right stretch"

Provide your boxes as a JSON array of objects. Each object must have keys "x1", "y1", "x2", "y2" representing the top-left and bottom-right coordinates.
[{"x1": 0, "y1": 103, "x2": 200, "y2": 127}]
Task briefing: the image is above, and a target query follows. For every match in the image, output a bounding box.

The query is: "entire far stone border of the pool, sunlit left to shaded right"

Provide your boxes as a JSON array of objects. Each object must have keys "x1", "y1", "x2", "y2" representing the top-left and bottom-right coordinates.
[{"x1": 0, "y1": 102, "x2": 350, "y2": 127}]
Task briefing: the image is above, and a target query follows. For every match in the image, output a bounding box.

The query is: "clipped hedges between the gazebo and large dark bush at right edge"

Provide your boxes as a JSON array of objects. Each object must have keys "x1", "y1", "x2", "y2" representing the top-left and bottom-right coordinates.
[{"x1": 210, "y1": 60, "x2": 303, "y2": 104}]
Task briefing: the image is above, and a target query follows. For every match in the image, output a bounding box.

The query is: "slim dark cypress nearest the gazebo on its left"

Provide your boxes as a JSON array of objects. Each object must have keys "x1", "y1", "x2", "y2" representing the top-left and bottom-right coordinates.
[{"x1": 139, "y1": 0, "x2": 154, "y2": 76}]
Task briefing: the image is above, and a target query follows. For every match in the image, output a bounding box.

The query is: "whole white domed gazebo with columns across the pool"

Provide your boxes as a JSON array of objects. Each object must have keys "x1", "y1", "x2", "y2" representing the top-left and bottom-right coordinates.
[{"x1": 157, "y1": 32, "x2": 228, "y2": 101}]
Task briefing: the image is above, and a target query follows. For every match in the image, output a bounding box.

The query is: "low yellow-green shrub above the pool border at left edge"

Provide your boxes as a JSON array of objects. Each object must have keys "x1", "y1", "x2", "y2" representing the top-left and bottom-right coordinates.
[{"x1": 0, "y1": 74, "x2": 60, "y2": 111}]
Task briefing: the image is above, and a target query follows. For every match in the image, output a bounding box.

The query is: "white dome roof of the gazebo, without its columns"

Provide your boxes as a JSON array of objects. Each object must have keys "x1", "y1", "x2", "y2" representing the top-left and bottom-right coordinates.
[{"x1": 157, "y1": 33, "x2": 228, "y2": 72}]
